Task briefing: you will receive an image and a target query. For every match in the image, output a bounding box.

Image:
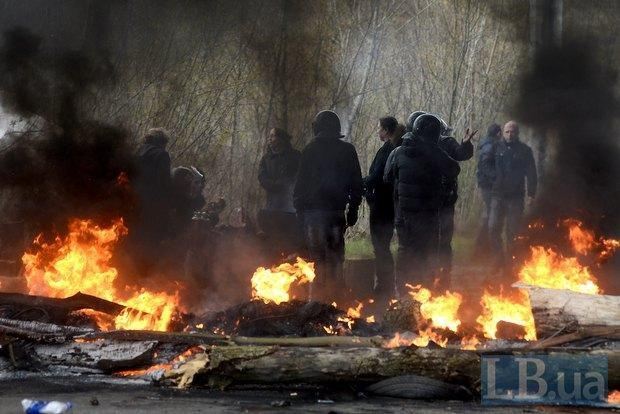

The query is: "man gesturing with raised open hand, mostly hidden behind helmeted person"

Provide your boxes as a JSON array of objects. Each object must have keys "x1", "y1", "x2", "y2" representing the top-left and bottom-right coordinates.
[{"x1": 437, "y1": 119, "x2": 478, "y2": 288}]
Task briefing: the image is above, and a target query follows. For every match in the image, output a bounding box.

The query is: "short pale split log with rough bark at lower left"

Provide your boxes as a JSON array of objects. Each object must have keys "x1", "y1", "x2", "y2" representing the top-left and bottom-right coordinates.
[{"x1": 31, "y1": 340, "x2": 157, "y2": 372}]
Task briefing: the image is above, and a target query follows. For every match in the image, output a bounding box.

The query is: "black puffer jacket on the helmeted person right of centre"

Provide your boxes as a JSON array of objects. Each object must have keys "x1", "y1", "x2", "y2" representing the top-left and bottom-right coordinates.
[{"x1": 384, "y1": 139, "x2": 461, "y2": 218}]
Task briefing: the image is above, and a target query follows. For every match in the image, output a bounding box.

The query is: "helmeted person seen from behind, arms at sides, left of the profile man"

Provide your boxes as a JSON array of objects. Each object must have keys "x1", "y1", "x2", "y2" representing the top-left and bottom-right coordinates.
[{"x1": 293, "y1": 111, "x2": 363, "y2": 302}]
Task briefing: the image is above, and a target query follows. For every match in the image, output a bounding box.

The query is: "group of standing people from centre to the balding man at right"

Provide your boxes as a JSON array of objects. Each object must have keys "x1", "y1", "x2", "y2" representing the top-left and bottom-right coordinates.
[{"x1": 259, "y1": 111, "x2": 537, "y2": 300}]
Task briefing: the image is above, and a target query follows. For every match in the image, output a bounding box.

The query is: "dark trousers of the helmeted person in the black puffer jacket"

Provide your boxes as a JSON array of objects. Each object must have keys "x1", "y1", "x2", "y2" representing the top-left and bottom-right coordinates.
[{"x1": 396, "y1": 211, "x2": 439, "y2": 290}]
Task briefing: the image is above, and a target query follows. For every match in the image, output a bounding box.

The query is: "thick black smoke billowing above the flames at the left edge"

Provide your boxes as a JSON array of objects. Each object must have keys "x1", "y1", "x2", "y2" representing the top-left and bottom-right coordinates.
[{"x1": 0, "y1": 28, "x2": 134, "y2": 231}]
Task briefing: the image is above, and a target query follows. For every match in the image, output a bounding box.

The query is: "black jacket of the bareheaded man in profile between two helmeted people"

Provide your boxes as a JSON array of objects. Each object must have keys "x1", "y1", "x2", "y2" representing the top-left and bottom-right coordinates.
[{"x1": 364, "y1": 141, "x2": 394, "y2": 211}]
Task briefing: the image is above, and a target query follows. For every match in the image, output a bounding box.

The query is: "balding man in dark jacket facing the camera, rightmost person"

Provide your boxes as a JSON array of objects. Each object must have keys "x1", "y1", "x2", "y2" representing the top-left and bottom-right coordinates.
[{"x1": 489, "y1": 121, "x2": 538, "y2": 270}]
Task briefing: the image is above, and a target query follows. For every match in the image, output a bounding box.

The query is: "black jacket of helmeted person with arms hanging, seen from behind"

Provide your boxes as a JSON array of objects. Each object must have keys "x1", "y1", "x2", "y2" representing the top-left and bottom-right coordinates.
[{"x1": 293, "y1": 138, "x2": 363, "y2": 211}]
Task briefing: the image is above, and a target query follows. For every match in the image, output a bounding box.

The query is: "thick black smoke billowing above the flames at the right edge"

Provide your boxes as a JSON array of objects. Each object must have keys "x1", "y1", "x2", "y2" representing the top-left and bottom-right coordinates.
[{"x1": 514, "y1": 39, "x2": 620, "y2": 234}]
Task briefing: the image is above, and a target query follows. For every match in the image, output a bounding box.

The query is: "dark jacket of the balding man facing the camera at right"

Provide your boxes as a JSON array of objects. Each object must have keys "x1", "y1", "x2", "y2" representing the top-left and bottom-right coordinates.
[{"x1": 492, "y1": 139, "x2": 538, "y2": 198}]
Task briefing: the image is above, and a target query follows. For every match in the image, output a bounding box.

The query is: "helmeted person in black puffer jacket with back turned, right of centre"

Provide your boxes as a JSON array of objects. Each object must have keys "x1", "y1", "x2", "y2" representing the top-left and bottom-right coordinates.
[{"x1": 384, "y1": 114, "x2": 460, "y2": 287}]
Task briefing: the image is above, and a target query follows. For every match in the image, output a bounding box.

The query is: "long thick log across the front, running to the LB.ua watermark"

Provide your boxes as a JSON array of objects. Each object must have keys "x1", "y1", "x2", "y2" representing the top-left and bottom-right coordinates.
[{"x1": 167, "y1": 346, "x2": 620, "y2": 390}]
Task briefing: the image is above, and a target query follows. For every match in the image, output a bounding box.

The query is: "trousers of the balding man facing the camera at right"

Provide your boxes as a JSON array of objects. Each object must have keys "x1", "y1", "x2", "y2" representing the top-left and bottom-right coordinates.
[{"x1": 489, "y1": 196, "x2": 523, "y2": 266}]
